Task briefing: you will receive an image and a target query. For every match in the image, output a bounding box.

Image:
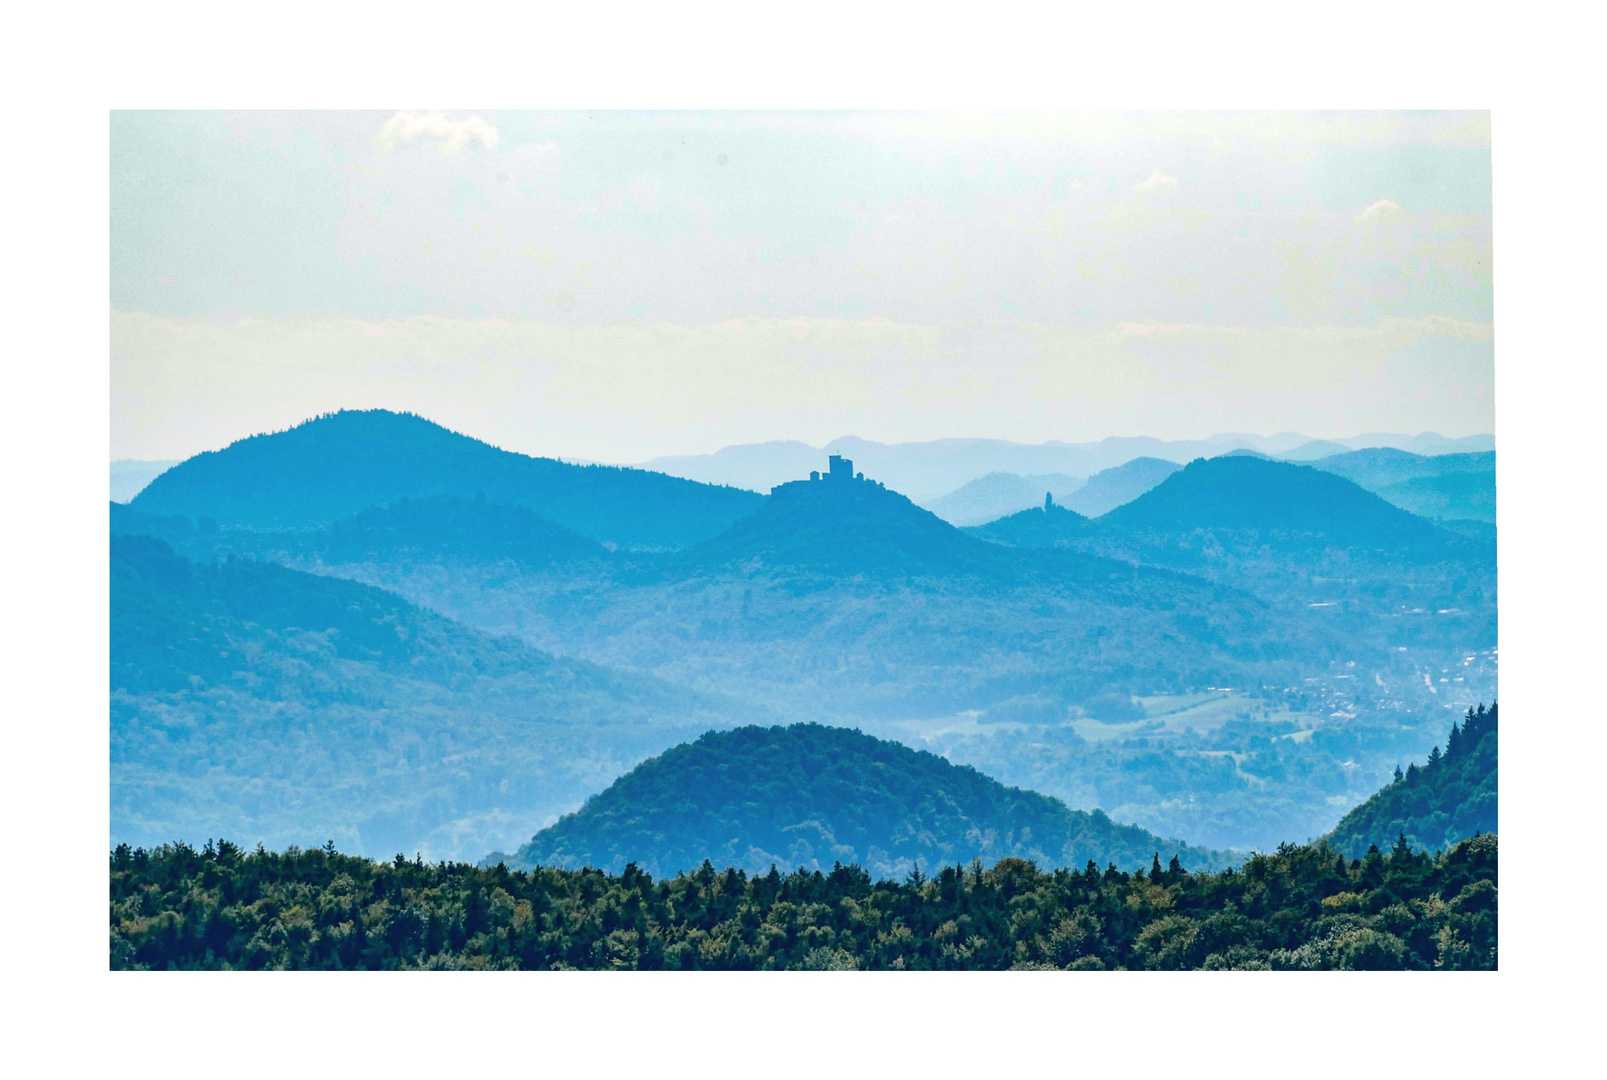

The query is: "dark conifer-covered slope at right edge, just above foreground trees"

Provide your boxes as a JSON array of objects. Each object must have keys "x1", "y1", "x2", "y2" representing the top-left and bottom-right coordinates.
[{"x1": 1327, "y1": 706, "x2": 1499, "y2": 855}]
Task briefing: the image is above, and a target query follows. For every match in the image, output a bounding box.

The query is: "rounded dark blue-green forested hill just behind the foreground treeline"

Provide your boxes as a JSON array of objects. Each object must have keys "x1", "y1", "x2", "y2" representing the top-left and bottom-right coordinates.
[{"x1": 492, "y1": 723, "x2": 1237, "y2": 878}]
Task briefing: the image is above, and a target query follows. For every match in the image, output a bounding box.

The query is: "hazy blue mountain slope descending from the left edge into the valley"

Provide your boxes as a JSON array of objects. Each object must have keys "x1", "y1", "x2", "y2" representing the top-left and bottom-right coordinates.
[{"x1": 111, "y1": 537, "x2": 754, "y2": 857}]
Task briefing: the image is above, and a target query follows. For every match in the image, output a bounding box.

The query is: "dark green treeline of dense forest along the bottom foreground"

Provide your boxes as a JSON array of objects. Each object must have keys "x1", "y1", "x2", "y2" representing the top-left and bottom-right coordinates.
[{"x1": 111, "y1": 834, "x2": 1496, "y2": 971}]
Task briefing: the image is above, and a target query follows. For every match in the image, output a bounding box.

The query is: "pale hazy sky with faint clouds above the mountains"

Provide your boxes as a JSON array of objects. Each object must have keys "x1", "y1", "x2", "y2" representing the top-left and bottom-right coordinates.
[{"x1": 111, "y1": 109, "x2": 1495, "y2": 461}]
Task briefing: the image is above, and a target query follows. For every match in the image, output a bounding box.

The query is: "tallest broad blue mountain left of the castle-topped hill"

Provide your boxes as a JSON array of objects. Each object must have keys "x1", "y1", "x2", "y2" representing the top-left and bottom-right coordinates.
[{"x1": 132, "y1": 410, "x2": 763, "y2": 548}]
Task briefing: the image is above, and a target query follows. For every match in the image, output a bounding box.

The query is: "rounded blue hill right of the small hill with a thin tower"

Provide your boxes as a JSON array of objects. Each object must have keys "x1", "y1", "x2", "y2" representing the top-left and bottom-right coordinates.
[{"x1": 1099, "y1": 455, "x2": 1458, "y2": 551}]
